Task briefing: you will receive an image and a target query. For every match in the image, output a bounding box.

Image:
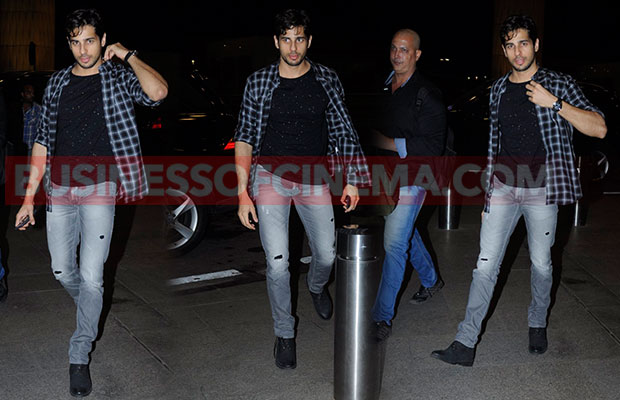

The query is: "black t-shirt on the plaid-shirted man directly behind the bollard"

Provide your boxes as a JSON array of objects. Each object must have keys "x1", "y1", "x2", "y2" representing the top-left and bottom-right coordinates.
[{"x1": 259, "y1": 69, "x2": 329, "y2": 183}]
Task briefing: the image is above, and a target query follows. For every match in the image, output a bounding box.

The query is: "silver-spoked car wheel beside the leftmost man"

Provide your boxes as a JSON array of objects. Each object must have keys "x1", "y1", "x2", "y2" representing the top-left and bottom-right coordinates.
[{"x1": 164, "y1": 189, "x2": 209, "y2": 256}]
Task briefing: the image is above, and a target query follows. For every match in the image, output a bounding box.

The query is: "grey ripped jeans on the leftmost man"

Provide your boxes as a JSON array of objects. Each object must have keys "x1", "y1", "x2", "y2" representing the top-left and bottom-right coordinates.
[{"x1": 47, "y1": 182, "x2": 116, "y2": 364}]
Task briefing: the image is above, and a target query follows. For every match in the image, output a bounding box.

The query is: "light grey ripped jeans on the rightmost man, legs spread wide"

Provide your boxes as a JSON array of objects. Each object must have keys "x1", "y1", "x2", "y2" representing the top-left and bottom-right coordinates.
[{"x1": 455, "y1": 179, "x2": 558, "y2": 348}]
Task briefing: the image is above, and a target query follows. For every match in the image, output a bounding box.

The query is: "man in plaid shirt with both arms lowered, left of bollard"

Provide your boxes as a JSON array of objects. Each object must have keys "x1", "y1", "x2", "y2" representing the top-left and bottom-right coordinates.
[{"x1": 235, "y1": 10, "x2": 368, "y2": 368}]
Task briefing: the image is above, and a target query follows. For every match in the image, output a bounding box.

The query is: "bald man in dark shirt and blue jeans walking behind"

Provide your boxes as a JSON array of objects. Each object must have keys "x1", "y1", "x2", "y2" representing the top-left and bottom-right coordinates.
[{"x1": 372, "y1": 29, "x2": 447, "y2": 341}]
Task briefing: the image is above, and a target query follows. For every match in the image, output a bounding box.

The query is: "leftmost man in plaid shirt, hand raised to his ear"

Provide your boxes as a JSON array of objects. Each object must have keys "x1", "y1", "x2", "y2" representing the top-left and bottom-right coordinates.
[{"x1": 15, "y1": 9, "x2": 168, "y2": 397}]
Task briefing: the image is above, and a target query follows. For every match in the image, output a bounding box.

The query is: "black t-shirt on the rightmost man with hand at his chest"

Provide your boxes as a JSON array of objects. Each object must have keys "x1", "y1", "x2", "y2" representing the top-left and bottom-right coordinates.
[{"x1": 495, "y1": 81, "x2": 547, "y2": 188}]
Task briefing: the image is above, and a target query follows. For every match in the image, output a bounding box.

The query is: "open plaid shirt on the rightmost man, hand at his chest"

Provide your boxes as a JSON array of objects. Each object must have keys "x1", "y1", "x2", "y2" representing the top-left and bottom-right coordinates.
[{"x1": 484, "y1": 68, "x2": 604, "y2": 212}]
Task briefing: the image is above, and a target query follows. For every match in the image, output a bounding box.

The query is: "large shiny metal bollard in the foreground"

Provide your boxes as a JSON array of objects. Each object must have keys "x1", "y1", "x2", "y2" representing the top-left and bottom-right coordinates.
[{"x1": 334, "y1": 228, "x2": 386, "y2": 400}]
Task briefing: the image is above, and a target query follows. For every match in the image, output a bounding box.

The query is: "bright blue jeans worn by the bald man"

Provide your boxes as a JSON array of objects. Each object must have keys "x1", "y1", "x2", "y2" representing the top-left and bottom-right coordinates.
[{"x1": 372, "y1": 186, "x2": 437, "y2": 323}]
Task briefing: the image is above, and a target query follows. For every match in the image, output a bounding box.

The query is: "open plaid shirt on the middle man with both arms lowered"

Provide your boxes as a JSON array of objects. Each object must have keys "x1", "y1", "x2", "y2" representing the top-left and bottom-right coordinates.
[{"x1": 234, "y1": 62, "x2": 370, "y2": 197}]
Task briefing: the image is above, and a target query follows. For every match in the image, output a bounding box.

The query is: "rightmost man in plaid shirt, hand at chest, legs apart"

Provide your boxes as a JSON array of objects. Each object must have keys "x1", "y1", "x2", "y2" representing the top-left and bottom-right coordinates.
[{"x1": 431, "y1": 15, "x2": 607, "y2": 366}]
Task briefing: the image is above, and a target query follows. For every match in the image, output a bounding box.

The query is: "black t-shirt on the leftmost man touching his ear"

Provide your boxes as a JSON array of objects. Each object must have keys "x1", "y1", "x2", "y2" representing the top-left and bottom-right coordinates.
[{"x1": 51, "y1": 74, "x2": 114, "y2": 186}]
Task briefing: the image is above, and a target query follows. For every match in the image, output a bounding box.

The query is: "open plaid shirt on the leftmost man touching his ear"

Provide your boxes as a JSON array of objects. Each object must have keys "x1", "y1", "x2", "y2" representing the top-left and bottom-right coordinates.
[{"x1": 35, "y1": 61, "x2": 161, "y2": 206}]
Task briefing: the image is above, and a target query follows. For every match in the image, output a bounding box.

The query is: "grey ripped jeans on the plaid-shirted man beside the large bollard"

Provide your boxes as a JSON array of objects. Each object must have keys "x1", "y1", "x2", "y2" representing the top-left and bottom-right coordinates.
[{"x1": 253, "y1": 165, "x2": 336, "y2": 339}]
